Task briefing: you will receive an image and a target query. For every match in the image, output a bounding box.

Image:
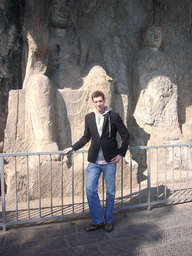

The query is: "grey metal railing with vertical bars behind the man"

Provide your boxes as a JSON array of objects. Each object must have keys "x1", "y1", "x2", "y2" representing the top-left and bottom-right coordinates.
[{"x1": 0, "y1": 143, "x2": 192, "y2": 231}]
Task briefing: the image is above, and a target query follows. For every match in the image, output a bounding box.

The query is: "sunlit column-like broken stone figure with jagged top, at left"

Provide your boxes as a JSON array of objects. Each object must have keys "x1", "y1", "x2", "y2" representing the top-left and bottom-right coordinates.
[{"x1": 23, "y1": 27, "x2": 58, "y2": 151}]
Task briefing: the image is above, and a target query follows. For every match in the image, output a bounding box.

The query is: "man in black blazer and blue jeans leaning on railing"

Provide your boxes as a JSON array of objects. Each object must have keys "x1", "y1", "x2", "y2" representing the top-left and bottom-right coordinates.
[{"x1": 65, "y1": 91, "x2": 129, "y2": 232}]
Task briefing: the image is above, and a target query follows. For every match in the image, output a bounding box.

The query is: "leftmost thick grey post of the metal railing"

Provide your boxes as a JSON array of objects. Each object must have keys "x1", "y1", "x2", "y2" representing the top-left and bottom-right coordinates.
[{"x1": 0, "y1": 155, "x2": 6, "y2": 231}]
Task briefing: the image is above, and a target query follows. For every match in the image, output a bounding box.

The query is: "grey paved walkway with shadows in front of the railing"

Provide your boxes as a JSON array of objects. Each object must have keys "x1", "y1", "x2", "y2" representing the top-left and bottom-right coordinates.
[{"x1": 0, "y1": 203, "x2": 192, "y2": 256}]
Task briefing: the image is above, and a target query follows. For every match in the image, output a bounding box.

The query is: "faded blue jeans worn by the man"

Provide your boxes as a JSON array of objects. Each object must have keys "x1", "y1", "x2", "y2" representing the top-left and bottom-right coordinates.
[{"x1": 86, "y1": 163, "x2": 116, "y2": 224}]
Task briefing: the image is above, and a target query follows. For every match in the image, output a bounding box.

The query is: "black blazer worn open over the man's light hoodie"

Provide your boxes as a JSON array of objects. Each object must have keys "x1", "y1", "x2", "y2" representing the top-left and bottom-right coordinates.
[{"x1": 72, "y1": 111, "x2": 130, "y2": 163}]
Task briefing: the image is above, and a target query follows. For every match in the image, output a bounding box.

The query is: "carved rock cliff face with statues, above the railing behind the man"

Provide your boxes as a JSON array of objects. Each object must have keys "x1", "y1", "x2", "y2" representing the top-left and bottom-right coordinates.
[{"x1": 0, "y1": 0, "x2": 192, "y2": 152}]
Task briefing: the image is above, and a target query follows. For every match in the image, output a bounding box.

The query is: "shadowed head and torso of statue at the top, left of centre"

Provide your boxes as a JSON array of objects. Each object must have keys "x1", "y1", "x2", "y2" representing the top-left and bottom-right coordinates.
[{"x1": 48, "y1": 0, "x2": 88, "y2": 89}]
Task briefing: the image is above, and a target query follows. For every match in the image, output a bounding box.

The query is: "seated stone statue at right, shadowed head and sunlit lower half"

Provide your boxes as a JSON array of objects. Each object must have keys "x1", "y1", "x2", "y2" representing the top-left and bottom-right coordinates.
[{"x1": 133, "y1": 26, "x2": 180, "y2": 144}]
